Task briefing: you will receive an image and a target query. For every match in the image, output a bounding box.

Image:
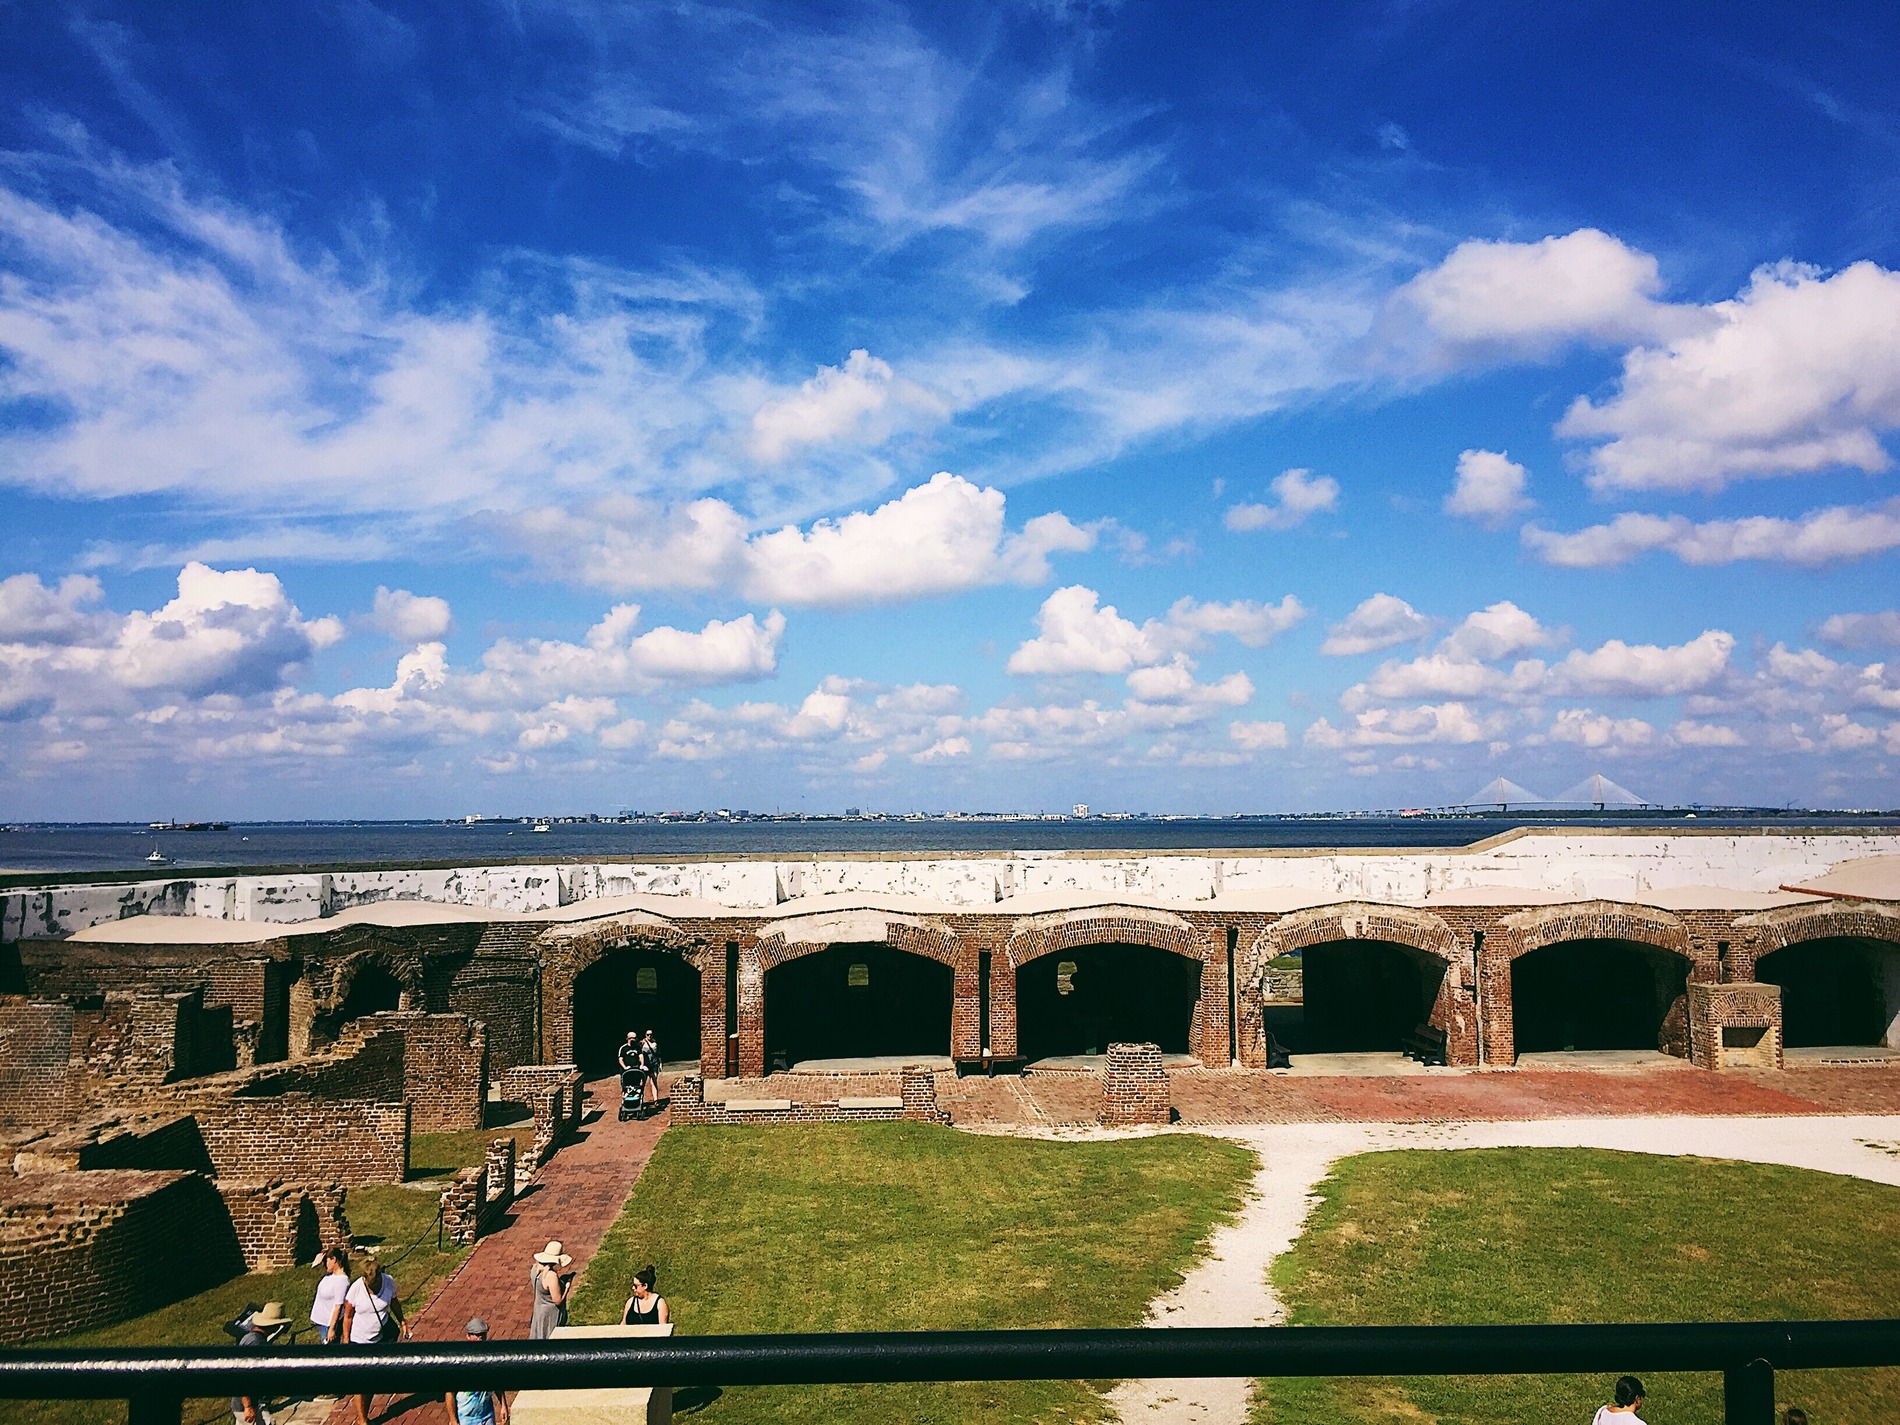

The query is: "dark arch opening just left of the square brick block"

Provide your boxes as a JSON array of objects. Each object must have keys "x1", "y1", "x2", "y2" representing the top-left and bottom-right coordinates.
[{"x1": 1511, "y1": 941, "x2": 1689, "y2": 1055}]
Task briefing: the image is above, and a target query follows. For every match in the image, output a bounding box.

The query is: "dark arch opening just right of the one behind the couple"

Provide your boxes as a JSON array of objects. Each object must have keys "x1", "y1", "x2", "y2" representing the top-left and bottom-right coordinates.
[{"x1": 766, "y1": 944, "x2": 956, "y2": 1068}]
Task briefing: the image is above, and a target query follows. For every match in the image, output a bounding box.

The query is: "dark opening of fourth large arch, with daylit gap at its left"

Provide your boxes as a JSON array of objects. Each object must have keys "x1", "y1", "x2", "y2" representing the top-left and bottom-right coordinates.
[{"x1": 1264, "y1": 941, "x2": 1446, "y2": 1055}]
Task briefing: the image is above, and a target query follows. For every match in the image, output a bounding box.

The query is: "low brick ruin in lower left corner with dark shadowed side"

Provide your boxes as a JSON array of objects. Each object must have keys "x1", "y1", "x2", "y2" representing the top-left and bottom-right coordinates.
[{"x1": 0, "y1": 1172, "x2": 243, "y2": 1343}]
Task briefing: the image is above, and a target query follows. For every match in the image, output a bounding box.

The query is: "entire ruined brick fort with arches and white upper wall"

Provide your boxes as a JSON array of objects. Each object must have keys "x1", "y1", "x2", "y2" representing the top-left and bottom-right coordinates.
[{"x1": 0, "y1": 827, "x2": 1900, "y2": 1340}]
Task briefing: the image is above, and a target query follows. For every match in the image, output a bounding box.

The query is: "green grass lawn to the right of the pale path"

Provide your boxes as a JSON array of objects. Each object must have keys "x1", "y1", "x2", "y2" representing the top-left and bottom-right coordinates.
[{"x1": 1254, "y1": 1155, "x2": 1900, "y2": 1425}]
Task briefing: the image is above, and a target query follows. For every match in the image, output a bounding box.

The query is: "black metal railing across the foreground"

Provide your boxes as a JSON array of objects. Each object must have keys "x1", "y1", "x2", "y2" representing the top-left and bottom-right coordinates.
[{"x1": 0, "y1": 1321, "x2": 1900, "y2": 1425}]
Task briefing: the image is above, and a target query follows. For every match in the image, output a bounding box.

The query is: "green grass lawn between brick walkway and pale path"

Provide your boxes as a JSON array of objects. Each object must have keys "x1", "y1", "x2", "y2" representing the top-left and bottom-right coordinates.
[{"x1": 570, "y1": 1123, "x2": 1254, "y2": 1425}]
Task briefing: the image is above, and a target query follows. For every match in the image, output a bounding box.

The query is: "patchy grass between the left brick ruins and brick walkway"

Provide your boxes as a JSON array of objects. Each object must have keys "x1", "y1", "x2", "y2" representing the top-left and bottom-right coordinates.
[{"x1": 0, "y1": 1184, "x2": 466, "y2": 1425}]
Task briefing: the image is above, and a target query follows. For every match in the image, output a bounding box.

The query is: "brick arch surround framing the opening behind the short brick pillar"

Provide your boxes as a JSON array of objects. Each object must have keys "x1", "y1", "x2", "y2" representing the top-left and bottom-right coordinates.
[{"x1": 990, "y1": 904, "x2": 1227, "y2": 1064}]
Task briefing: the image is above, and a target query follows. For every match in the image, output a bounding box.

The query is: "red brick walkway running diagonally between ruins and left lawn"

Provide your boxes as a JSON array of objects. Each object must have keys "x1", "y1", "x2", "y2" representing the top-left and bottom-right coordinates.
[{"x1": 329, "y1": 1079, "x2": 667, "y2": 1425}]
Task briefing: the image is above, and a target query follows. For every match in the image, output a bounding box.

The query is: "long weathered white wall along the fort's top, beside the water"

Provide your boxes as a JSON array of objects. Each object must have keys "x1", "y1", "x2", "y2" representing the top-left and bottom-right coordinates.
[{"x1": 0, "y1": 828, "x2": 1900, "y2": 941}]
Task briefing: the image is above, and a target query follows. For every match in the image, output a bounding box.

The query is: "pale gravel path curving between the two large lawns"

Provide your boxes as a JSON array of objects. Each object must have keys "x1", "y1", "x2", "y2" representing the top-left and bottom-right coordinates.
[{"x1": 1108, "y1": 1115, "x2": 1900, "y2": 1425}]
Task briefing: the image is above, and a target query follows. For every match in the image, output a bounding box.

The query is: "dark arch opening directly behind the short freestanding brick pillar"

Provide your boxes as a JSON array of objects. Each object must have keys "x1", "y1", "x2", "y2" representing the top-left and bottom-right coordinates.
[{"x1": 1017, "y1": 944, "x2": 1201, "y2": 1060}]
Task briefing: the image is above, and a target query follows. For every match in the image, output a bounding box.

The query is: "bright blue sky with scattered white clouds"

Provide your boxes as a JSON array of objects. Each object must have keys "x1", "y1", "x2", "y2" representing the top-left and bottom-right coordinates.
[{"x1": 0, "y1": 0, "x2": 1900, "y2": 819}]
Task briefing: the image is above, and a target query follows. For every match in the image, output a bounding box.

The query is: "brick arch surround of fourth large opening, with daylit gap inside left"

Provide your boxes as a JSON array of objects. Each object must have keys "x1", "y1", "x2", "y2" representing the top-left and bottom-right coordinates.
[{"x1": 1237, "y1": 901, "x2": 1478, "y2": 1064}]
